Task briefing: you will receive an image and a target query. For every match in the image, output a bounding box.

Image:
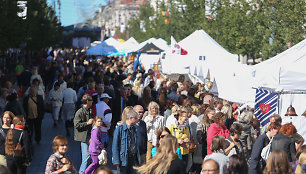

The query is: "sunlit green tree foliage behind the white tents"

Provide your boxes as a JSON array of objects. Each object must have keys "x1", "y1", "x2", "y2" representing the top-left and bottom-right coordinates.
[{"x1": 129, "y1": 0, "x2": 306, "y2": 59}]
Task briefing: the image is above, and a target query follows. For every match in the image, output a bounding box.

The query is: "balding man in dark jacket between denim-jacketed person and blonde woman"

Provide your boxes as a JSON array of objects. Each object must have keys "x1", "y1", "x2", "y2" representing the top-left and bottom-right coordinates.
[{"x1": 134, "y1": 105, "x2": 148, "y2": 165}]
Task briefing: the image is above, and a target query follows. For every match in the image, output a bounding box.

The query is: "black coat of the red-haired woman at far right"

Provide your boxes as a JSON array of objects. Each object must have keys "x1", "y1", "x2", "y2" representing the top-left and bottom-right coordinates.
[{"x1": 271, "y1": 133, "x2": 296, "y2": 162}]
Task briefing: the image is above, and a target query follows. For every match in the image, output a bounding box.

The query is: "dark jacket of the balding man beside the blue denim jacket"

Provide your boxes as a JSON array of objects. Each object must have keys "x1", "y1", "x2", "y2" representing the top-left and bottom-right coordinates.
[{"x1": 136, "y1": 120, "x2": 148, "y2": 155}]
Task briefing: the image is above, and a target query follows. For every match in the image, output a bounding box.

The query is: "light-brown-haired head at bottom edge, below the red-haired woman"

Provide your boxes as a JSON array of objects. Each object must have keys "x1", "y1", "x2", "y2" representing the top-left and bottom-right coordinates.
[{"x1": 264, "y1": 150, "x2": 291, "y2": 174}]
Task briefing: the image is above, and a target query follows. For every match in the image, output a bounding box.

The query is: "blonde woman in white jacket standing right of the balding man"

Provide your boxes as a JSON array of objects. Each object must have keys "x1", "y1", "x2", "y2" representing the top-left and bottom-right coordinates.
[{"x1": 144, "y1": 102, "x2": 165, "y2": 161}]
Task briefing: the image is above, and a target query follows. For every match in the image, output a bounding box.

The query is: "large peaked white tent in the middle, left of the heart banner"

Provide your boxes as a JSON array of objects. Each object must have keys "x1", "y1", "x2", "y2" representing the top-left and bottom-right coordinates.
[{"x1": 162, "y1": 30, "x2": 255, "y2": 103}]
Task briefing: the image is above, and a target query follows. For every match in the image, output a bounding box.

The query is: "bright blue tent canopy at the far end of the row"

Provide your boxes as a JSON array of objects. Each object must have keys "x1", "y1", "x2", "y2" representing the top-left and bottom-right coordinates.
[{"x1": 86, "y1": 42, "x2": 118, "y2": 56}]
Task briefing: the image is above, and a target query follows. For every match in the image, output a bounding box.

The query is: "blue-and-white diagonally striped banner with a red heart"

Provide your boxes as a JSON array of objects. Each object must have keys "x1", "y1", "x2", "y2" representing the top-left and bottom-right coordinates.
[{"x1": 255, "y1": 89, "x2": 278, "y2": 126}]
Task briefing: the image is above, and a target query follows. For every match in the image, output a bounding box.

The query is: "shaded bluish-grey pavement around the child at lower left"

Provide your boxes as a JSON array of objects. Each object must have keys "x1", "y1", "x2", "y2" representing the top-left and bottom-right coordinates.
[{"x1": 27, "y1": 113, "x2": 116, "y2": 174}]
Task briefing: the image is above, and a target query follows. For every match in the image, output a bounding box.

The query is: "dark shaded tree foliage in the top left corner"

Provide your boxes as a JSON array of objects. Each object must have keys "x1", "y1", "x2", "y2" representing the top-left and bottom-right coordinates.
[{"x1": 0, "y1": 0, "x2": 62, "y2": 50}]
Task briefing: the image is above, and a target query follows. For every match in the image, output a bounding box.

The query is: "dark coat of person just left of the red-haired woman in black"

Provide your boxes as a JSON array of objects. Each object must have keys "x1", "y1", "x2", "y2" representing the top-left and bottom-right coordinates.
[{"x1": 249, "y1": 134, "x2": 270, "y2": 174}]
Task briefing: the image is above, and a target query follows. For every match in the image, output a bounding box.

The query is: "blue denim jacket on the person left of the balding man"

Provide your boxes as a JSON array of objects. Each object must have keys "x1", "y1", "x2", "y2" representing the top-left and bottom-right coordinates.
[{"x1": 112, "y1": 122, "x2": 141, "y2": 166}]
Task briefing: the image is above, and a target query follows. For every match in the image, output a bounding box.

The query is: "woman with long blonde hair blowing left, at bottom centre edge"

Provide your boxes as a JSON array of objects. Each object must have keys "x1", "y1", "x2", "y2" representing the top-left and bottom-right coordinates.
[{"x1": 135, "y1": 135, "x2": 186, "y2": 174}]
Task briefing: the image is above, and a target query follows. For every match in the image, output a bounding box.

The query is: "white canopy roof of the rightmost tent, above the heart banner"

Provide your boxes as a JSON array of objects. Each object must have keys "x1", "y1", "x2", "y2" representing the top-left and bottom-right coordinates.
[{"x1": 253, "y1": 39, "x2": 306, "y2": 90}]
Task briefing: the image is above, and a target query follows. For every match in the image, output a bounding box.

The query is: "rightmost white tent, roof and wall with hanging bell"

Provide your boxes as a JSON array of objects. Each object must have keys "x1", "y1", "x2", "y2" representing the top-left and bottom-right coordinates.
[{"x1": 253, "y1": 39, "x2": 306, "y2": 139}]
